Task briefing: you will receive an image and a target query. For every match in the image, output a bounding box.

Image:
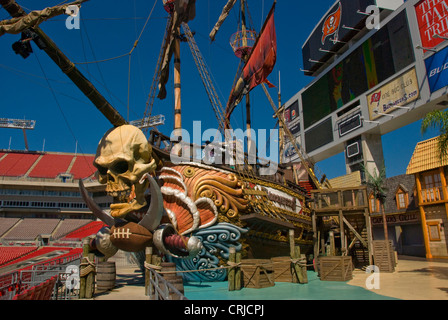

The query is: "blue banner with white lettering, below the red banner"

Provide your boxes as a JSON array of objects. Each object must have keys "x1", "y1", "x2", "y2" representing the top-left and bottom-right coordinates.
[{"x1": 425, "y1": 43, "x2": 448, "y2": 93}]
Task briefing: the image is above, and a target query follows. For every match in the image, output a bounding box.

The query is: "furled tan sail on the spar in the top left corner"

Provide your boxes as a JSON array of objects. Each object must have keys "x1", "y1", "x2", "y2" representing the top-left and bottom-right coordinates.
[{"x1": 0, "y1": 0, "x2": 86, "y2": 36}]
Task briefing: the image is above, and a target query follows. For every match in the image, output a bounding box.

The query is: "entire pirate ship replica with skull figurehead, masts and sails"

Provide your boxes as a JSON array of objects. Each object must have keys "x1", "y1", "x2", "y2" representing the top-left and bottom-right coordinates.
[{"x1": 0, "y1": 0, "x2": 321, "y2": 280}]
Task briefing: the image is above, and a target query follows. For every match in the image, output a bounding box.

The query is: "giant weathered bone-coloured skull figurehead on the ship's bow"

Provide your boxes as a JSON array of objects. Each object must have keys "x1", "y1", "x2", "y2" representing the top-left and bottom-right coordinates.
[{"x1": 94, "y1": 125, "x2": 157, "y2": 218}]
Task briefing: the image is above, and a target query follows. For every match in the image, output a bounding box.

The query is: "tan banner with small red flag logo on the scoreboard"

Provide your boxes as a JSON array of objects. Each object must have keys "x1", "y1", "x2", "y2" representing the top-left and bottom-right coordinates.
[{"x1": 367, "y1": 68, "x2": 420, "y2": 120}]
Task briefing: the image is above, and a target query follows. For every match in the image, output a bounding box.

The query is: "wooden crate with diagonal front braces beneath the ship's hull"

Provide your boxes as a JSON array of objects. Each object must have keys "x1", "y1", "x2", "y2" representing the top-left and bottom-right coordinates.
[{"x1": 241, "y1": 259, "x2": 275, "y2": 289}]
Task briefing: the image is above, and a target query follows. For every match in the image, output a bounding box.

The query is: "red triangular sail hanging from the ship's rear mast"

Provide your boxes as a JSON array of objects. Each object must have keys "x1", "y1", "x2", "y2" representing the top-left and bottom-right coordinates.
[{"x1": 226, "y1": 2, "x2": 277, "y2": 119}]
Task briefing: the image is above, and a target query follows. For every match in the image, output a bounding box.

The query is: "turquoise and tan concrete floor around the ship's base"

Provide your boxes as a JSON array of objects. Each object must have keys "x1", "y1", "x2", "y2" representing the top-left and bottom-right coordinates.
[{"x1": 89, "y1": 257, "x2": 448, "y2": 301}]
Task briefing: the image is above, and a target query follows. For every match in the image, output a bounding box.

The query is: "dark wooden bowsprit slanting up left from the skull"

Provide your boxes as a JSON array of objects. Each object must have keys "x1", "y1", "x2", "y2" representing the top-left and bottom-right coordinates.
[{"x1": 0, "y1": 0, "x2": 127, "y2": 127}]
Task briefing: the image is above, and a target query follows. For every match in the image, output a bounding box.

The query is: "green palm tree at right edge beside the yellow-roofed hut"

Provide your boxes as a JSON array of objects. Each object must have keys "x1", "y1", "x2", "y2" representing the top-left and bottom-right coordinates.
[{"x1": 421, "y1": 109, "x2": 448, "y2": 161}]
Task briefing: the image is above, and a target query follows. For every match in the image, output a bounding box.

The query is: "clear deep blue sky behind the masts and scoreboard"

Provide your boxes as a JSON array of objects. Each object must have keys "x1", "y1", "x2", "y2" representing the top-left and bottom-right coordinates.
[{"x1": 0, "y1": 0, "x2": 436, "y2": 178}]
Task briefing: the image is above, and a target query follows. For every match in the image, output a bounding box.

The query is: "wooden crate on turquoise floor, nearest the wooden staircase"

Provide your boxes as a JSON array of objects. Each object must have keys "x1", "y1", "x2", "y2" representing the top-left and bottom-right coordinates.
[{"x1": 319, "y1": 256, "x2": 353, "y2": 281}]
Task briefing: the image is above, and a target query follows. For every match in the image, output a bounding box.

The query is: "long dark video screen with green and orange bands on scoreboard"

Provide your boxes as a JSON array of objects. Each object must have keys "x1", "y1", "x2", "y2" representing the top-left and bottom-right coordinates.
[{"x1": 302, "y1": 11, "x2": 415, "y2": 129}]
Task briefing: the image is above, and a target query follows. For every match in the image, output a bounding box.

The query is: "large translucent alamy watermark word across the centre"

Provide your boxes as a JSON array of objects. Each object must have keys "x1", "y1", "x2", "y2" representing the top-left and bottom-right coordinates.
[{"x1": 170, "y1": 121, "x2": 279, "y2": 176}]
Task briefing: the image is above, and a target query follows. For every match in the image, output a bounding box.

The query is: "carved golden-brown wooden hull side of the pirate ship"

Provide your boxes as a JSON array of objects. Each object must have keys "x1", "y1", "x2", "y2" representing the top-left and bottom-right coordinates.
[{"x1": 156, "y1": 153, "x2": 312, "y2": 258}]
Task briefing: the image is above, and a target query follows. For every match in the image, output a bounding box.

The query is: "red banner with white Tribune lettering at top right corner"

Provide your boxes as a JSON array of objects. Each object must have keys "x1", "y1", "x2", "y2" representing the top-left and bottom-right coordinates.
[{"x1": 415, "y1": 0, "x2": 448, "y2": 48}]
